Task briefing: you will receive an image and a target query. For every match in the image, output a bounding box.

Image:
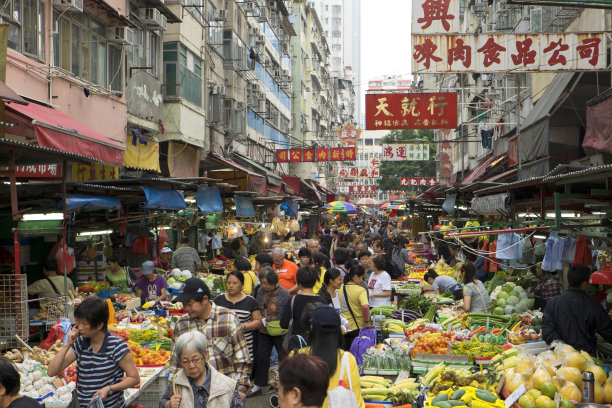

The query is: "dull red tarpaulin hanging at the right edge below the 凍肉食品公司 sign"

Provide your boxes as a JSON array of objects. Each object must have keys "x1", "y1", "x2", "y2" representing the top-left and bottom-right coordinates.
[{"x1": 582, "y1": 98, "x2": 612, "y2": 153}]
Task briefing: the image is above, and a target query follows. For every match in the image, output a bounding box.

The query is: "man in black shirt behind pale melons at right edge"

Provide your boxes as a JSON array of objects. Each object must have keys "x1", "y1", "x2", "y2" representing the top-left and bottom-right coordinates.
[{"x1": 542, "y1": 265, "x2": 612, "y2": 354}]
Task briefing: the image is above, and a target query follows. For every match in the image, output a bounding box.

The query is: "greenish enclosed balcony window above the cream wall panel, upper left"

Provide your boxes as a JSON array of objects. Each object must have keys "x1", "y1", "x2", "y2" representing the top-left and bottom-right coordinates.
[{"x1": 164, "y1": 42, "x2": 202, "y2": 107}]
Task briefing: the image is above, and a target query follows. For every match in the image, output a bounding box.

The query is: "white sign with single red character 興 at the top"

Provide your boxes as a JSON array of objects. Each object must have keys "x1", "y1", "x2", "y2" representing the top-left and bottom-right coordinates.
[{"x1": 412, "y1": 0, "x2": 460, "y2": 34}]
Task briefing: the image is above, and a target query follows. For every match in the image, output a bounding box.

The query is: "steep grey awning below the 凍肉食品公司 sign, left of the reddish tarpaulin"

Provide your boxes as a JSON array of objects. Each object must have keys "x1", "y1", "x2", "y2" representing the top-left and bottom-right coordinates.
[{"x1": 518, "y1": 72, "x2": 582, "y2": 163}]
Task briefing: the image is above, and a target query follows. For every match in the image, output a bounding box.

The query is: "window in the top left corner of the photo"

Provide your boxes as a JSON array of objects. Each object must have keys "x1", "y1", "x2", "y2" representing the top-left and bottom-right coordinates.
[{"x1": 0, "y1": 0, "x2": 45, "y2": 61}]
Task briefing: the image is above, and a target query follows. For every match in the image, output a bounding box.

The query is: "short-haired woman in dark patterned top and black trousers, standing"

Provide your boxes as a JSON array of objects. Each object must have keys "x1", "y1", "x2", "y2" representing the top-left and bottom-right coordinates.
[{"x1": 247, "y1": 266, "x2": 291, "y2": 398}]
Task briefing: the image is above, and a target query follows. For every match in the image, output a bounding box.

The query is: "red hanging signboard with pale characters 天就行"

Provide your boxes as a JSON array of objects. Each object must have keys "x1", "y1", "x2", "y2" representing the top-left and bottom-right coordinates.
[{"x1": 366, "y1": 92, "x2": 457, "y2": 130}]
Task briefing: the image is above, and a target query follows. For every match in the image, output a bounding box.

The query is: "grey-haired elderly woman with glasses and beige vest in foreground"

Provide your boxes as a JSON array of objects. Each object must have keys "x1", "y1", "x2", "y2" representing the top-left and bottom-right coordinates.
[{"x1": 159, "y1": 331, "x2": 243, "y2": 408}]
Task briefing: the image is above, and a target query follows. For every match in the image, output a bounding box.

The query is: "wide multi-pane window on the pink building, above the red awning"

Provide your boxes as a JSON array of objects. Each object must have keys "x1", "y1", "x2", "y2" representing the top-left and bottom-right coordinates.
[{"x1": 53, "y1": 13, "x2": 124, "y2": 92}]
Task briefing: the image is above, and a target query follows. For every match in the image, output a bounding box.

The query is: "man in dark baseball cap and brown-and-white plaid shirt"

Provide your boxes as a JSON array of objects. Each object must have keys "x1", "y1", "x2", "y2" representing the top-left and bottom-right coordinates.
[{"x1": 170, "y1": 278, "x2": 252, "y2": 400}]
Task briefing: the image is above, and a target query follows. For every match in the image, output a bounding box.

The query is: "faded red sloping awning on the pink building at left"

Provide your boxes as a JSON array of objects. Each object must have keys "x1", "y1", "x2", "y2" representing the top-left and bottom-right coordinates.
[{"x1": 6, "y1": 102, "x2": 124, "y2": 166}]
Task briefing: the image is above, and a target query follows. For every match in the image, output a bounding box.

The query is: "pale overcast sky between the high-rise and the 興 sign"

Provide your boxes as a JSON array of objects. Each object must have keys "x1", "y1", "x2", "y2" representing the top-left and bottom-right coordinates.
[{"x1": 360, "y1": 0, "x2": 412, "y2": 110}]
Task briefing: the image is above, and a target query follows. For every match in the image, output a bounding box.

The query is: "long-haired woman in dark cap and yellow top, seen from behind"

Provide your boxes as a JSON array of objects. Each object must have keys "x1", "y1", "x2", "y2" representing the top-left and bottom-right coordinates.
[{"x1": 297, "y1": 306, "x2": 365, "y2": 408}]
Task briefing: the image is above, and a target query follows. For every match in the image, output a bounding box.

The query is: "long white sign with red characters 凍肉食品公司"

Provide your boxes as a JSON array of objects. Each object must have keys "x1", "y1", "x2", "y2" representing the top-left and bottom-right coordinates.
[{"x1": 412, "y1": 33, "x2": 607, "y2": 72}]
